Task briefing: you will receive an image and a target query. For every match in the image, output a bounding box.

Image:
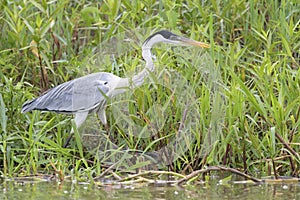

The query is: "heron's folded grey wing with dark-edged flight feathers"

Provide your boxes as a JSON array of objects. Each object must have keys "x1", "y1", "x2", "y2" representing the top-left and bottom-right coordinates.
[{"x1": 22, "y1": 73, "x2": 109, "y2": 113}]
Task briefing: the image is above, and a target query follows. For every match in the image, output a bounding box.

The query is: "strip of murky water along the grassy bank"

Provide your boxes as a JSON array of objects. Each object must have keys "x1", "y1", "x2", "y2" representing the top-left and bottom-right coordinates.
[{"x1": 0, "y1": 181, "x2": 300, "y2": 200}]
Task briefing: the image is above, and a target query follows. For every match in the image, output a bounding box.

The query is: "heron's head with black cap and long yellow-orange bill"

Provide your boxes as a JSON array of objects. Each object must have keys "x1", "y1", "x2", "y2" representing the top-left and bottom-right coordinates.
[{"x1": 143, "y1": 30, "x2": 209, "y2": 48}]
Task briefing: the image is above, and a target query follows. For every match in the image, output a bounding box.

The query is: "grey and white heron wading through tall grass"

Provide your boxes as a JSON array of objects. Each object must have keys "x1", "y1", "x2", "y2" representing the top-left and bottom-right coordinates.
[{"x1": 21, "y1": 30, "x2": 209, "y2": 147}]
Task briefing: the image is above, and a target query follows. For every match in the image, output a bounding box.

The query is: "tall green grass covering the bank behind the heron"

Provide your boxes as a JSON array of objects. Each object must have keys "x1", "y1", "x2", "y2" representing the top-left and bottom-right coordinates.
[{"x1": 0, "y1": 0, "x2": 300, "y2": 179}]
